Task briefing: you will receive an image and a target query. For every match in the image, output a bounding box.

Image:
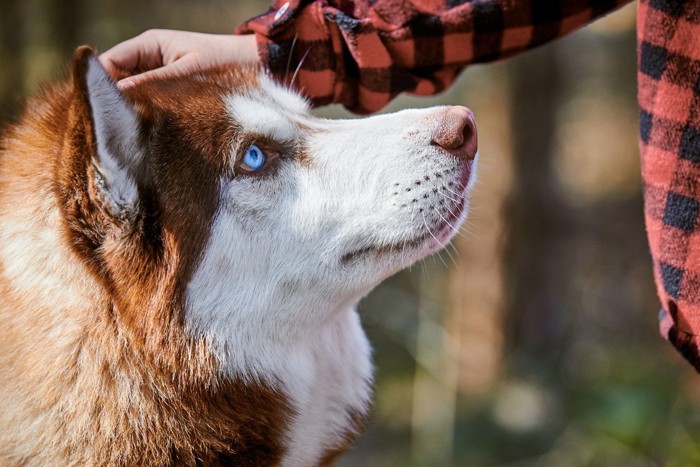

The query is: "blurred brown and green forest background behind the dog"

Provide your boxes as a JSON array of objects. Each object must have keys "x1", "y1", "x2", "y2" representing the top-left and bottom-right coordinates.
[{"x1": 0, "y1": 0, "x2": 700, "y2": 467}]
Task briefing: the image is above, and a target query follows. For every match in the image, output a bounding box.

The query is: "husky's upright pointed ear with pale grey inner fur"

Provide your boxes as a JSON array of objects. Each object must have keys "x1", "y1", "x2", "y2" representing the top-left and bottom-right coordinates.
[{"x1": 71, "y1": 46, "x2": 145, "y2": 219}]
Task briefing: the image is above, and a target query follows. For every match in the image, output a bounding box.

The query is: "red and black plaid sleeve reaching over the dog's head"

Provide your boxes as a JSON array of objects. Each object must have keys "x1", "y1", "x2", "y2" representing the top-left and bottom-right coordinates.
[{"x1": 237, "y1": 0, "x2": 629, "y2": 113}]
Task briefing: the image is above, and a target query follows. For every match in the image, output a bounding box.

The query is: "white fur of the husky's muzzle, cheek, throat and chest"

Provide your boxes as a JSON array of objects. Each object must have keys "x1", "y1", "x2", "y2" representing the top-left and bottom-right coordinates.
[{"x1": 186, "y1": 78, "x2": 474, "y2": 465}]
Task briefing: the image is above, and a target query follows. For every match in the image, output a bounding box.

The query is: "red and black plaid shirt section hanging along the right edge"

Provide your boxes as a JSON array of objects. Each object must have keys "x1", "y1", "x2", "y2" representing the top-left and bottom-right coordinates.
[{"x1": 637, "y1": 0, "x2": 700, "y2": 371}]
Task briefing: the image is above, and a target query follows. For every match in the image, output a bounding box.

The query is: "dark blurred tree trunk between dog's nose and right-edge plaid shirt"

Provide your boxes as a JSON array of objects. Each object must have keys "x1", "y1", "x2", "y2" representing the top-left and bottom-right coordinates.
[{"x1": 503, "y1": 46, "x2": 568, "y2": 369}]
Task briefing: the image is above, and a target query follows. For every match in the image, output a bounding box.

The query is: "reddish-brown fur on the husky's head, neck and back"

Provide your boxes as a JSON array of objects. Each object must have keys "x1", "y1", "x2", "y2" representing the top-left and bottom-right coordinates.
[{"x1": 0, "y1": 49, "x2": 291, "y2": 465}]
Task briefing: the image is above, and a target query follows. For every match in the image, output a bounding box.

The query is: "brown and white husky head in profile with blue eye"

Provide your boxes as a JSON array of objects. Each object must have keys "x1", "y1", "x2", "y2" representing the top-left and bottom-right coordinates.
[{"x1": 57, "y1": 48, "x2": 476, "y2": 372}]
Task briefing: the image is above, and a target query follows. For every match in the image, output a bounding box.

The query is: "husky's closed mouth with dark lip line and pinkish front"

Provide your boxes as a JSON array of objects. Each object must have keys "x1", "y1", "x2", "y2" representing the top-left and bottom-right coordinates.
[{"x1": 340, "y1": 189, "x2": 467, "y2": 265}]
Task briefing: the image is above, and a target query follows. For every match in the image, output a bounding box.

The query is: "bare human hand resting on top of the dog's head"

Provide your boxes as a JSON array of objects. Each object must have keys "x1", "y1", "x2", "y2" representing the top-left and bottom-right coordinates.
[{"x1": 99, "y1": 29, "x2": 258, "y2": 89}]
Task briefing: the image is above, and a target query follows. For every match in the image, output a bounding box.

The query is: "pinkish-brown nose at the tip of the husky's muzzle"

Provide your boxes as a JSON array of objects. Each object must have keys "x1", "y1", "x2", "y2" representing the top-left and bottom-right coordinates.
[{"x1": 431, "y1": 105, "x2": 477, "y2": 160}]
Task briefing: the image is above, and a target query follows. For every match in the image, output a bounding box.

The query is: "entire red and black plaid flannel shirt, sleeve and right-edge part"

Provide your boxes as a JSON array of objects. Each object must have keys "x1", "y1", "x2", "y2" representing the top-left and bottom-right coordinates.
[{"x1": 237, "y1": 0, "x2": 700, "y2": 371}]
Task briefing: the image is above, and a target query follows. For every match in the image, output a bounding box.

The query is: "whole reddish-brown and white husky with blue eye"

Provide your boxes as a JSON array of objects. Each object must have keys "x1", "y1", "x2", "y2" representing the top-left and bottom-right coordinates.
[{"x1": 0, "y1": 47, "x2": 476, "y2": 466}]
